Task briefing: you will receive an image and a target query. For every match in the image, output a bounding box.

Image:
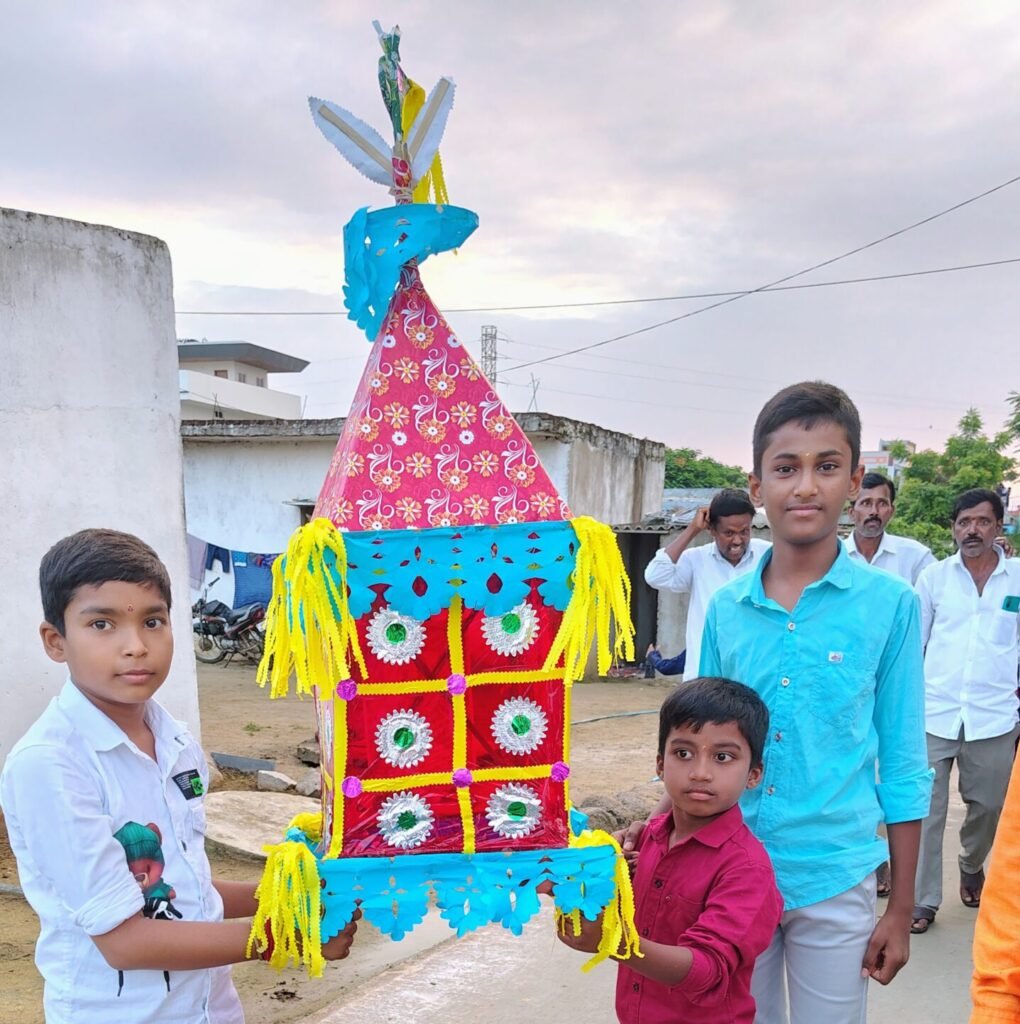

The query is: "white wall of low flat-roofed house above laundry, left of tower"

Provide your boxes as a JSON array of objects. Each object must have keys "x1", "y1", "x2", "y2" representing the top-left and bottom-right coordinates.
[{"x1": 184, "y1": 437, "x2": 336, "y2": 605}]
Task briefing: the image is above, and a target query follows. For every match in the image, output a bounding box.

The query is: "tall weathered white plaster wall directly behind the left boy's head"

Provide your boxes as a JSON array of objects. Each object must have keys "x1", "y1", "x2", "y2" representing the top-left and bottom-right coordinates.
[{"x1": 0, "y1": 209, "x2": 199, "y2": 761}]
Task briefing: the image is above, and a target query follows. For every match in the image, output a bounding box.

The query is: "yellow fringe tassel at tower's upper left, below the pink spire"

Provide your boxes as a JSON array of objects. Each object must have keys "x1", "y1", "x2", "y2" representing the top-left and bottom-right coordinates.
[{"x1": 255, "y1": 518, "x2": 366, "y2": 697}]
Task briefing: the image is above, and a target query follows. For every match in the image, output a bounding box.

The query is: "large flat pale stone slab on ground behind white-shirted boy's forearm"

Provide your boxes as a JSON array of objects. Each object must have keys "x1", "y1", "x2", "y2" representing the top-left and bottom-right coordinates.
[{"x1": 206, "y1": 790, "x2": 321, "y2": 860}]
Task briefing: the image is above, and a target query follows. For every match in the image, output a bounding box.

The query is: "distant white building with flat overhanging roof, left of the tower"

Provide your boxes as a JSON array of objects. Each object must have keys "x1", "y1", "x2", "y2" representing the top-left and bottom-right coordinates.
[{"x1": 177, "y1": 338, "x2": 308, "y2": 420}]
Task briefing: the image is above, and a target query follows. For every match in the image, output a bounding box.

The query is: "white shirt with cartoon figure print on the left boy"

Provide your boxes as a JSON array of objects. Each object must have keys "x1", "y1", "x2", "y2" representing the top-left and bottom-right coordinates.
[{"x1": 0, "y1": 681, "x2": 244, "y2": 1024}]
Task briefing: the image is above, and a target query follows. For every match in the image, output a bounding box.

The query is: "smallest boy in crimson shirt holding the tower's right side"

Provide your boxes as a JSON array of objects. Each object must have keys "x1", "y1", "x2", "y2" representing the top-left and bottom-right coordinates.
[{"x1": 559, "y1": 679, "x2": 782, "y2": 1024}]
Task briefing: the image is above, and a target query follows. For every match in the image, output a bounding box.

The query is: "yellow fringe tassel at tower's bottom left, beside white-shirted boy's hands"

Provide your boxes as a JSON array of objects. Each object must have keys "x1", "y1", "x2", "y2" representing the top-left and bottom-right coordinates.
[{"x1": 247, "y1": 842, "x2": 326, "y2": 978}]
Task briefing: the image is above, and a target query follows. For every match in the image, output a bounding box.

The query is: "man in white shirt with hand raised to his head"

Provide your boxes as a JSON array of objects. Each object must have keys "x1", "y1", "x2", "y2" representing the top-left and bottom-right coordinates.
[{"x1": 644, "y1": 487, "x2": 771, "y2": 679}]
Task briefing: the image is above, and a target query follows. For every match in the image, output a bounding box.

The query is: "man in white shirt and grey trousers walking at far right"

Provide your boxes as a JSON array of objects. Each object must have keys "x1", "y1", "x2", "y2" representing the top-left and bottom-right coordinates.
[{"x1": 912, "y1": 489, "x2": 1020, "y2": 934}]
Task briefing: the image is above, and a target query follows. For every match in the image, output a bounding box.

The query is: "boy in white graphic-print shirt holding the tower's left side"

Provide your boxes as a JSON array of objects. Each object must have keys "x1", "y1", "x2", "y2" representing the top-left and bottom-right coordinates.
[{"x1": 0, "y1": 529, "x2": 356, "y2": 1024}]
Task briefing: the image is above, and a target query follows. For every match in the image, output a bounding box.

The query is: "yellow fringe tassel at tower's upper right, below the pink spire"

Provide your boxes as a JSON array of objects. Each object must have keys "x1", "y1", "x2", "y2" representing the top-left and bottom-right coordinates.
[{"x1": 549, "y1": 516, "x2": 634, "y2": 683}]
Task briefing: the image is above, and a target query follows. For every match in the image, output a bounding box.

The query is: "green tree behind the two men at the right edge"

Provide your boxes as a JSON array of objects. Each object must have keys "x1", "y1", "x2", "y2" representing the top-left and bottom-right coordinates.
[{"x1": 889, "y1": 409, "x2": 1014, "y2": 558}]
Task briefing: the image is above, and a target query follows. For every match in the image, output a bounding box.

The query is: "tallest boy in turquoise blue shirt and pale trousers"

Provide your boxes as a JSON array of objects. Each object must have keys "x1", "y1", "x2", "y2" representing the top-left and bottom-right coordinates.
[{"x1": 628, "y1": 382, "x2": 931, "y2": 1024}]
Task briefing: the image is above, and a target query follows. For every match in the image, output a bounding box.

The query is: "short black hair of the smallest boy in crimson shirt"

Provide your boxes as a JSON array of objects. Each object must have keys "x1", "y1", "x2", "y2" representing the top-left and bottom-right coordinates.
[{"x1": 658, "y1": 676, "x2": 768, "y2": 768}]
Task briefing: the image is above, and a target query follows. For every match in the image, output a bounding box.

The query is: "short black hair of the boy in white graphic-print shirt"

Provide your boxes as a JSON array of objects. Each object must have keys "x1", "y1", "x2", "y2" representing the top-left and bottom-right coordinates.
[{"x1": 39, "y1": 529, "x2": 170, "y2": 636}]
